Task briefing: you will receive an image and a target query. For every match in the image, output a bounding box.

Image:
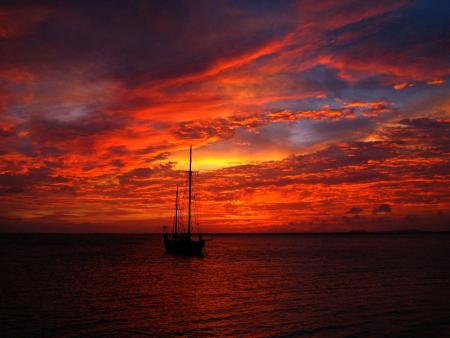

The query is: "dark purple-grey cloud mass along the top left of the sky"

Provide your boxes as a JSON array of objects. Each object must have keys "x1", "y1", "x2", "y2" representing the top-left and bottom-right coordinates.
[{"x1": 0, "y1": 1, "x2": 295, "y2": 85}]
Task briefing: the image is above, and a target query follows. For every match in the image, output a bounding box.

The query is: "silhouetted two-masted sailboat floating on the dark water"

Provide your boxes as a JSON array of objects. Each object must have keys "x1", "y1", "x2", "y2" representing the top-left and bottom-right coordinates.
[{"x1": 164, "y1": 146, "x2": 205, "y2": 256}]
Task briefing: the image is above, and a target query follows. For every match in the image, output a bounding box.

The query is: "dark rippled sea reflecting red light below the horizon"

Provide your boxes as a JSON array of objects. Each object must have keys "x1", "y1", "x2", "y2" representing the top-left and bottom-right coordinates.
[{"x1": 0, "y1": 234, "x2": 450, "y2": 337}]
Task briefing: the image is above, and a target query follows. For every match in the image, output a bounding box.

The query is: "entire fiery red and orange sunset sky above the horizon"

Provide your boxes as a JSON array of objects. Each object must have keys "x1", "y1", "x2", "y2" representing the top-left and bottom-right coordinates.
[{"x1": 0, "y1": 0, "x2": 450, "y2": 232}]
